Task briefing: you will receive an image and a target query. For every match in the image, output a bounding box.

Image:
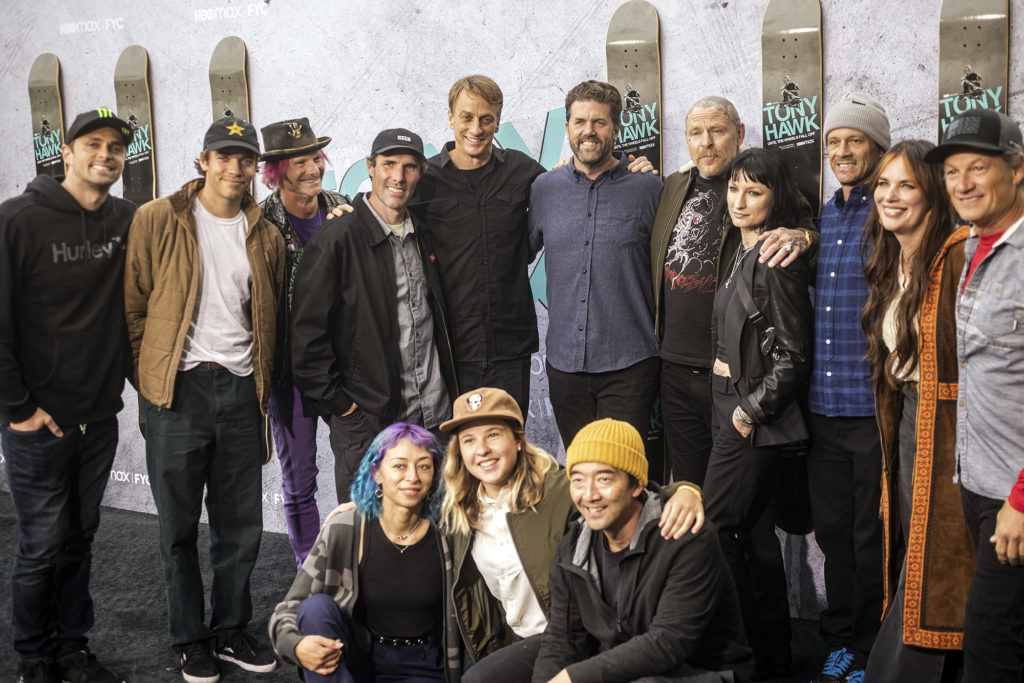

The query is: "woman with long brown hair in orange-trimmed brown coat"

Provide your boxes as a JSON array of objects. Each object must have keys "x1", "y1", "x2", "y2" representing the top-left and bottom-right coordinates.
[{"x1": 861, "y1": 140, "x2": 974, "y2": 683}]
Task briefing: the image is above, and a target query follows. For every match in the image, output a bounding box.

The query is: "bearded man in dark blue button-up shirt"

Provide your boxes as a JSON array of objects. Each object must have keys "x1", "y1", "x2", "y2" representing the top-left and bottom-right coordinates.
[{"x1": 529, "y1": 81, "x2": 662, "y2": 454}]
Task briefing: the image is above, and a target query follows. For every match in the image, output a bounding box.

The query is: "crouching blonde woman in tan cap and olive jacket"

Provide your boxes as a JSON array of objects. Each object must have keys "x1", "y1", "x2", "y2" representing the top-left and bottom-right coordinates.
[{"x1": 441, "y1": 388, "x2": 703, "y2": 681}]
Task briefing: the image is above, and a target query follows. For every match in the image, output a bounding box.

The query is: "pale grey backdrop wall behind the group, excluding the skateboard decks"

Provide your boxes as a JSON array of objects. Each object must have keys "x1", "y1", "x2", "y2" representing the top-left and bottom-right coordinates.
[{"x1": 0, "y1": 0, "x2": 1024, "y2": 616}]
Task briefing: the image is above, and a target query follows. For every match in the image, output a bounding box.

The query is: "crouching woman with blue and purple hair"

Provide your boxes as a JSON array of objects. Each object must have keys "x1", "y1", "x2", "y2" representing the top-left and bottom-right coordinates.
[{"x1": 269, "y1": 423, "x2": 461, "y2": 683}]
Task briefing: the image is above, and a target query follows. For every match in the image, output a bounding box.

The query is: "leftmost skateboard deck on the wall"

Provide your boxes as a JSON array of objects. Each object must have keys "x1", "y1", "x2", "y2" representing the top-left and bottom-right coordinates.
[{"x1": 29, "y1": 52, "x2": 65, "y2": 178}]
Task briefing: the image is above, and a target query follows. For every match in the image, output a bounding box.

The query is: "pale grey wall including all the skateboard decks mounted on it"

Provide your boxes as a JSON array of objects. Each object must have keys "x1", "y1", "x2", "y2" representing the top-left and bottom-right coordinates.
[{"x1": 0, "y1": 0, "x2": 1024, "y2": 615}]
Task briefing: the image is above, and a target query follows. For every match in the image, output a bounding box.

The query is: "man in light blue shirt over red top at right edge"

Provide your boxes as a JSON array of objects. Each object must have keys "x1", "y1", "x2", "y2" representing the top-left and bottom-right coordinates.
[{"x1": 925, "y1": 110, "x2": 1024, "y2": 683}]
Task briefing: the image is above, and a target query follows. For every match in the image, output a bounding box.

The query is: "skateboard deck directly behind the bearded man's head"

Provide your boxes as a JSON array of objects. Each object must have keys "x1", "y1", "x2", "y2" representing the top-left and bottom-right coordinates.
[{"x1": 605, "y1": 0, "x2": 662, "y2": 172}]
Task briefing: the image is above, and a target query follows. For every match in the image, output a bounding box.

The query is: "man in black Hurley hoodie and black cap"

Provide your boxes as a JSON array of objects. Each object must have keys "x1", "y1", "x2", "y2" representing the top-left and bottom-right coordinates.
[{"x1": 0, "y1": 109, "x2": 135, "y2": 683}]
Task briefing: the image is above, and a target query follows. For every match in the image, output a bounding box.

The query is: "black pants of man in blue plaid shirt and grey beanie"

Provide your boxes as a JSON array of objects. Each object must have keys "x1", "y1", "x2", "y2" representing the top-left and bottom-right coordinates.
[{"x1": 807, "y1": 413, "x2": 882, "y2": 666}]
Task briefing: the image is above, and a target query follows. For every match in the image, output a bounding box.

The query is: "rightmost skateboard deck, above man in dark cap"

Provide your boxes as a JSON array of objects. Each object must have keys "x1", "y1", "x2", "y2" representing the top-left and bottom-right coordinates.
[{"x1": 939, "y1": 0, "x2": 1010, "y2": 140}]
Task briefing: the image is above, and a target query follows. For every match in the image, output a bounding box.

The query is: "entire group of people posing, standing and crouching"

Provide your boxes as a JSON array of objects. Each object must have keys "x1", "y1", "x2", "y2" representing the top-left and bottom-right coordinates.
[{"x1": 0, "y1": 68, "x2": 1024, "y2": 683}]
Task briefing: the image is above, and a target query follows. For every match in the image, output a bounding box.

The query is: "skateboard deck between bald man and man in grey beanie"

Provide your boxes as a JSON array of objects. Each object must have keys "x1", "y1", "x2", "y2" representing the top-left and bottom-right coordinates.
[{"x1": 761, "y1": 0, "x2": 823, "y2": 216}]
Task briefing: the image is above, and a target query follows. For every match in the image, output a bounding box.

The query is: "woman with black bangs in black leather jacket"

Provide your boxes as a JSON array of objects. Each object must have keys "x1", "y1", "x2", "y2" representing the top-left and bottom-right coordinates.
[{"x1": 705, "y1": 150, "x2": 812, "y2": 677}]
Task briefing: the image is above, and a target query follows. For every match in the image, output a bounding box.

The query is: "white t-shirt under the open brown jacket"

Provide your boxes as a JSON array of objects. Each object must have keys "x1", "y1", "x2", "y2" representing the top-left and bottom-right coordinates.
[{"x1": 179, "y1": 197, "x2": 253, "y2": 377}]
